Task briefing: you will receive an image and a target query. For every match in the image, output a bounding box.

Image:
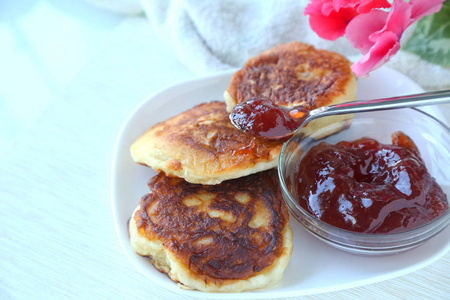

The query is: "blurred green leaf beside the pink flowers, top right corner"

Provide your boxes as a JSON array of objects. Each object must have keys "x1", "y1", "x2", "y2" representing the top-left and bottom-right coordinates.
[{"x1": 403, "y1": 0, "x2": 450, "y2": 67}]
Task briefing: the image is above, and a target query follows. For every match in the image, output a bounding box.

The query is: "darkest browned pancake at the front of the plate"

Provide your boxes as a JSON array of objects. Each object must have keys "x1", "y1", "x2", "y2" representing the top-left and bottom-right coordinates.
[{"x1": 129, "y1": 170, "x2": 292, "y2": 292}]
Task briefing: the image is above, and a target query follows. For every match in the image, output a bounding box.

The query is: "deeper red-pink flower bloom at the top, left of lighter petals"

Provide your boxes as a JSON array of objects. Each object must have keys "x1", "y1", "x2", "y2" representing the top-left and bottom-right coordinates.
[{"x1": 304, "y1": 0, "x2": 391, "y2": 40}]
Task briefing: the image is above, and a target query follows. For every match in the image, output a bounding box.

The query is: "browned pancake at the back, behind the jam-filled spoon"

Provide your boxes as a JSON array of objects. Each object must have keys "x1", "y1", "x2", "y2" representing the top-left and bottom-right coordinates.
[{"x1": 224, "y1": 41, "x2": 356, "y2": 138}]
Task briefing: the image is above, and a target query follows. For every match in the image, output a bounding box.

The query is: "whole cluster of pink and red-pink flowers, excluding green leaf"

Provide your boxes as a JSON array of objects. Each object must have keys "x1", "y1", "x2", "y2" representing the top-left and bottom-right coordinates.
[{"x1": 304, "y1": 0, "x2": 445, "y2": 76}]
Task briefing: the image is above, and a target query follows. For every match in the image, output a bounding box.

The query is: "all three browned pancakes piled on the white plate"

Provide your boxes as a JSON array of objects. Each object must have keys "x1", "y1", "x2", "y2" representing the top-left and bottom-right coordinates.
[{"x1": 129, "y1": 42, "x2": 356, "y2": 292}]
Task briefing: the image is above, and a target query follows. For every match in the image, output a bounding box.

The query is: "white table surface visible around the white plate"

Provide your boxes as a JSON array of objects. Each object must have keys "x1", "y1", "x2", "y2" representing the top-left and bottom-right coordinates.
[{"x1": 0, "y1": 0, "x2": 450, "y2": 299}]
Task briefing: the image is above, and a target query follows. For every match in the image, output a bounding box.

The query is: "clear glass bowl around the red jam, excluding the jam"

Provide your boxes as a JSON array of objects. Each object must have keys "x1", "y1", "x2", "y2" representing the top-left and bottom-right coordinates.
[{"x1": 278, "y1": 109, "x2": 450, "y2": 255}]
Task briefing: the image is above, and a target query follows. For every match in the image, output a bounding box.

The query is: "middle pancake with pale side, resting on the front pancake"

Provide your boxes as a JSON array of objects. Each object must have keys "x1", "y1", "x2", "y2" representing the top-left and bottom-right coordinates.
[{"x1": 130, "y1": 101, "x2": 282, "y2": 184}]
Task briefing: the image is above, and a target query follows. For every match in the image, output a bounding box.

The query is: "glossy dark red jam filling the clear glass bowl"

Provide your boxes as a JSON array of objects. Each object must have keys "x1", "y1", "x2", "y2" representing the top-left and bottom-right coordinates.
[{"x1": 295, "y1": 132, "x2": 448, "y2": 233}]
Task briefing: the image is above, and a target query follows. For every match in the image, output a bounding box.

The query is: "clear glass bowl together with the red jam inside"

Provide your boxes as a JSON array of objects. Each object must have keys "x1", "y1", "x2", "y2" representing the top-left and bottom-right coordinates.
[{"x1": 278, "y1": 109, "x2": 450, "y2": 255}]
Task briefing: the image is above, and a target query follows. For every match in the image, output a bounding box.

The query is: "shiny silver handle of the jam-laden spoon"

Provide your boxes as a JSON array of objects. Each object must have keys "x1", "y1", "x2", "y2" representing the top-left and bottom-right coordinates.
[{"x1": 310, "y1": 90, "x2": 450, "y2": 118}]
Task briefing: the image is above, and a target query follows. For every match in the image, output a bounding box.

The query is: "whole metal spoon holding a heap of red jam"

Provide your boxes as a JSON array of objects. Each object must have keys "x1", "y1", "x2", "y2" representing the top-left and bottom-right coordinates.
[{"x1": 230, "y1": 90, "x2": 450, "y2": 140}]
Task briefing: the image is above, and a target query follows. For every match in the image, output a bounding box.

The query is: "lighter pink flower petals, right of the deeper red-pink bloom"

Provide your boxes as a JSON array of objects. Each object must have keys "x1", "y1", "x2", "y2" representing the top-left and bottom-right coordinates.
[{"x1": 345, "y1": 0, "x2": 444, "y2": 76}]
